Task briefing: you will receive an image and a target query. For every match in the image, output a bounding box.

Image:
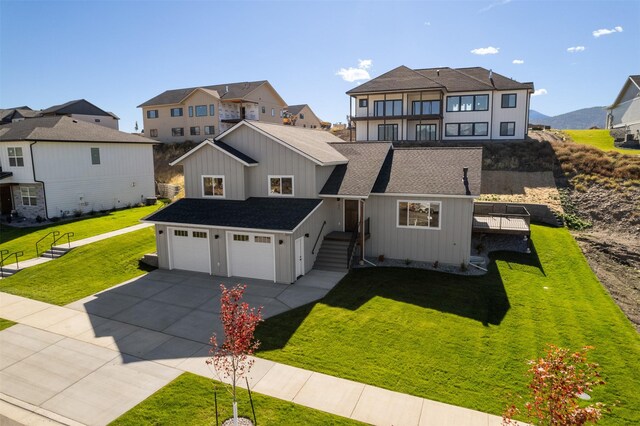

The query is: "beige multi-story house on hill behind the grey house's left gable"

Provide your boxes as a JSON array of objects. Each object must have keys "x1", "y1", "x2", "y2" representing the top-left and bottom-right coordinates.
[{"x1": 138, "y1": 80, "x2": 287, "y2": 142}]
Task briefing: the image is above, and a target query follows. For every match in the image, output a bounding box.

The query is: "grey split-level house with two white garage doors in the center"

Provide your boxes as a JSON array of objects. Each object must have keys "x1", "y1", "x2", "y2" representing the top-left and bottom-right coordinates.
[{"x1": 144, "y1": 121, "x2": 482, "y2": 283}]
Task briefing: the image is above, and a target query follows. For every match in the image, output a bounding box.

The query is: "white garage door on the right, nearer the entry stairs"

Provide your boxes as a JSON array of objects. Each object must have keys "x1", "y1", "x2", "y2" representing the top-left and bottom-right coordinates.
[{"x1": 227, "y1": 232, "x2": 275, "y2": 281}]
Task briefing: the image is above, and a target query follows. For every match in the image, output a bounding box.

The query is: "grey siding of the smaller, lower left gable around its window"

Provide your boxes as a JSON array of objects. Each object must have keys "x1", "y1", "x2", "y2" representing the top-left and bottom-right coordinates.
[{"x1": 182, "y1": 146, "x2": 246, "y2": 200}]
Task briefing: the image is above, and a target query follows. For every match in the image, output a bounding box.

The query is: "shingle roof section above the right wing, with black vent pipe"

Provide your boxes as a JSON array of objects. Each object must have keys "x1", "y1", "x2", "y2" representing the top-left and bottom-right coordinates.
[{"x1": 371, "y1": 148, "x2": 482, "y2": 195}]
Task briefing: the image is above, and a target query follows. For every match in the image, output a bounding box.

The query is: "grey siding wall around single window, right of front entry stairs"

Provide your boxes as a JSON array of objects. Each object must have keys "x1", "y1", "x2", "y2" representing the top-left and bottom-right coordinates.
[{"x1": 365, "y1": 195, "x2": 473, "y2": 265}]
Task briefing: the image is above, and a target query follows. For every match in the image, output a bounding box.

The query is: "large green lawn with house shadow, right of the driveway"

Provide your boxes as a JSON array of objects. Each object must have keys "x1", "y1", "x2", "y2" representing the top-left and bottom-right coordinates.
[{"x1": 257, "y1": 226, "x2": 640, "y2": 424}]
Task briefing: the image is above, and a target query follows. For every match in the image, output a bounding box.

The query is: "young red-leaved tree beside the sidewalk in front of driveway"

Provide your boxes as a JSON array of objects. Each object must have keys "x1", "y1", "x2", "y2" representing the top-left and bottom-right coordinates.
[{"x1": 206, "y1": 284, "x2": 262, "y2": 426}]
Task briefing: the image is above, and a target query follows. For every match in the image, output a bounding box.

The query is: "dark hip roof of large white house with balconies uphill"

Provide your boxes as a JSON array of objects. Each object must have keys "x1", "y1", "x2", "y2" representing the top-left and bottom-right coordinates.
[{"x1": 347, "y1": 65, "x2": 533, "y2": 95}]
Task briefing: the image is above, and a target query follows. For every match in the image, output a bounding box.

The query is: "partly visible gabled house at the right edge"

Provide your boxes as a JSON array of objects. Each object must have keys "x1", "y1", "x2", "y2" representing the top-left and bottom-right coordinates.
[{"x1": 607, "y1": 75, "x2": 640, "y2": 139}]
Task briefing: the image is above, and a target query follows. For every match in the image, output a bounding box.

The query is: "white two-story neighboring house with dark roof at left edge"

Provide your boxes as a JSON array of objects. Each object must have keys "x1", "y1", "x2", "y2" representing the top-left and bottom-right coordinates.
[{"x1": 0, "y1": 116, "x2": 155, "y2": 219}]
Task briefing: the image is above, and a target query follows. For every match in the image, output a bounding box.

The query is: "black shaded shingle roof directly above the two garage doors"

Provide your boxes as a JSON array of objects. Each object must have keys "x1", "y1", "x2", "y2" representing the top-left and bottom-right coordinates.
[{"x1": 144, "y1": 197, "x2": 322, "y2": 232}]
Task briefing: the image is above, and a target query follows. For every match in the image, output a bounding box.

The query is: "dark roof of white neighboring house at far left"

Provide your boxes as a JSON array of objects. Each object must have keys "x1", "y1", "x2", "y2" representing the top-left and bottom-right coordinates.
[{"x1": 0, "y1": 115, "x2": 157, "y2": 144}]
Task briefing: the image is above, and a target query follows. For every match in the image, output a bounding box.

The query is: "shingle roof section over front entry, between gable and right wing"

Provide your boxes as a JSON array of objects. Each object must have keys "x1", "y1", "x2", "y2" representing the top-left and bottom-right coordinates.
[{"x1": 320, "y1": 142, "x2": 391, "y2": 197}]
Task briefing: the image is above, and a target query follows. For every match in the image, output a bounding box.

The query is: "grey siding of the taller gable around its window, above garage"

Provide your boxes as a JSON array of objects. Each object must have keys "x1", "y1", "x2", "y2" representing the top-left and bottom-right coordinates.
[{"x1": 223, "y1": 126, "x2": 317, "y2": 198}]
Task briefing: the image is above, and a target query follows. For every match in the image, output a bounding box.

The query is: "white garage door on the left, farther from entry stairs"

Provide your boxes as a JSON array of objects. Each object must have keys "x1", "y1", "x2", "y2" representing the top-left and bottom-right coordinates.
[{"x1": 168, "y1": 228, "x2": 211, "y2": 274}]
